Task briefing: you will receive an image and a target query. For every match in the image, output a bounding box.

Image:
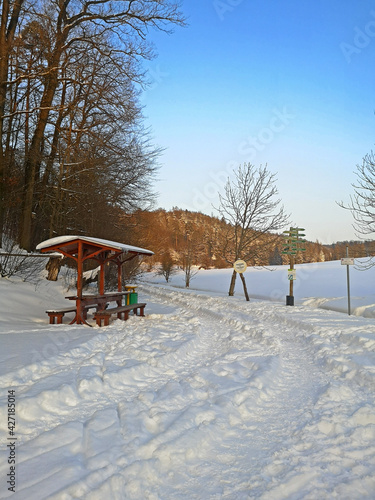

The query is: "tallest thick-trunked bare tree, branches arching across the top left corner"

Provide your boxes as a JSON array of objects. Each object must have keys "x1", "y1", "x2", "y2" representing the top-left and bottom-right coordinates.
[{"x1": 0, "y1": 0, "x2": 183, "y2": 249}]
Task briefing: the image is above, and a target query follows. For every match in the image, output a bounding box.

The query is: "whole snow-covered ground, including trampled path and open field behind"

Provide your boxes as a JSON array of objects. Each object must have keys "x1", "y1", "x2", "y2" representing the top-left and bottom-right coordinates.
[{"x1": 0, "y1": 262, "x2": 375, "y2": 500}]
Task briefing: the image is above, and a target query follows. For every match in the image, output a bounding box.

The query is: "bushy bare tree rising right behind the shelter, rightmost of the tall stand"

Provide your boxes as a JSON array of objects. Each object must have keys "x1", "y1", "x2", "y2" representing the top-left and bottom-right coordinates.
[{"x1": 34, "y1": 33, "x2": 158, "y2": 239}]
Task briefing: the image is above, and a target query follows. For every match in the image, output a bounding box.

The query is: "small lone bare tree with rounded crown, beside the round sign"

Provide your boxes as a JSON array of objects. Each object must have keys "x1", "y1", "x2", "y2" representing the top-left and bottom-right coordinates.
[{"x1": 218, "y1": 163, "x2": 289, "y2": 300}]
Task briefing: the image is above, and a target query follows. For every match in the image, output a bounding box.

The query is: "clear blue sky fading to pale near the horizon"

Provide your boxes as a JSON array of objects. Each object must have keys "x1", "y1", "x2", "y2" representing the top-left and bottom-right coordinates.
[{"x1": 142, "y1": 0, "x2": 375, "y2": 243}]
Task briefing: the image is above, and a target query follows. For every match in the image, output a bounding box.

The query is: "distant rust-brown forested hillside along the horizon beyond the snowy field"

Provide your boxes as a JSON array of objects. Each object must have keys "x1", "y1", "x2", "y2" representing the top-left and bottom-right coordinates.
[{"x1": 120, "y1": 208, "x2": 375, "y2": 269}]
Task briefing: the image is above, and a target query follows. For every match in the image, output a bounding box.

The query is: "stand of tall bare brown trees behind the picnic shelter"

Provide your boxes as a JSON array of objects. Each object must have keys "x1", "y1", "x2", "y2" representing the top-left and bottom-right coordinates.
[{"x1": 0, "y1": 0, "x2": 183, "y2": 250}]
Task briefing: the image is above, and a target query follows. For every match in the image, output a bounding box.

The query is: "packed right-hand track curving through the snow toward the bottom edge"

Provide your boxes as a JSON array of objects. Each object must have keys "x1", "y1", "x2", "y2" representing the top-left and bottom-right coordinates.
[{"x1": 135, "y1": 289, "x2": 328, "y2": 498}]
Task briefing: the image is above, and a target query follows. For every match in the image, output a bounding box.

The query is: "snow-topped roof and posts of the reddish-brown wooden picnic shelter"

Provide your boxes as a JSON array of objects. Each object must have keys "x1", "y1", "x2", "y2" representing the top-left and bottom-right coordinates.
[{"x1": 36, "y1": 236, "x2": 154, "y2": 323}]
